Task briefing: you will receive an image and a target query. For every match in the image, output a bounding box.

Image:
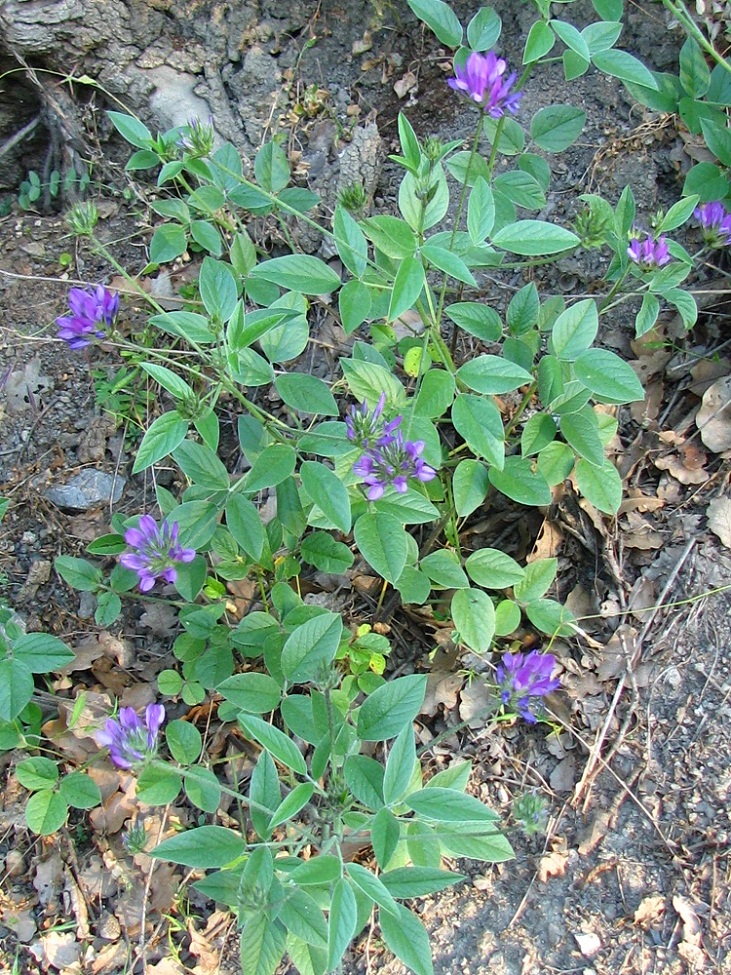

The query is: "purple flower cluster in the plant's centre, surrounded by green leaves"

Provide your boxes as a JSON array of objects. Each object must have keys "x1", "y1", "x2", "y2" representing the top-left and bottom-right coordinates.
[{"x1": 345, "y1": 393, "x2": 437, "y2": 501}]
